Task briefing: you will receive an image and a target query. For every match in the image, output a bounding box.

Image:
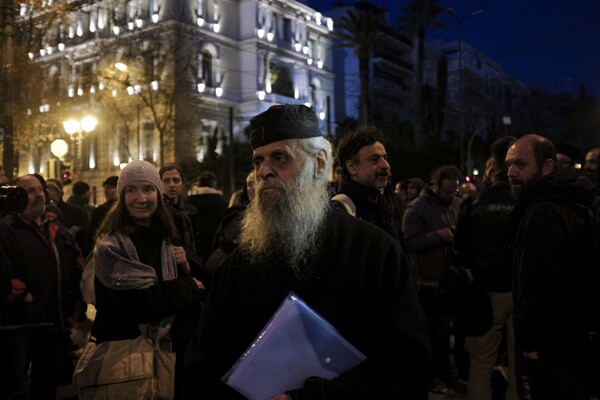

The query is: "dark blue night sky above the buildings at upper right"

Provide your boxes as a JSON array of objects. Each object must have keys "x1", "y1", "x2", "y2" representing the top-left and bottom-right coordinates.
[{"x1": 309, "y1": 0, "x2": 600, "y2": 99}]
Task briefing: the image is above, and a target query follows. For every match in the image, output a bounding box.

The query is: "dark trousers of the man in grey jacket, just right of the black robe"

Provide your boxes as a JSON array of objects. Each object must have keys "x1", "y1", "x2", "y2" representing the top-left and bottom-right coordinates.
[{"x1": 418, "y1": 286, "x2": 451, "y2": 385}]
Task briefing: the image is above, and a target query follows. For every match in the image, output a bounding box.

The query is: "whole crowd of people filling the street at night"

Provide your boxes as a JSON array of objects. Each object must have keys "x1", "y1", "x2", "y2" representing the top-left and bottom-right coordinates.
[{"x1": 0, "y1": 105, "x2": 600, "y2": 400}]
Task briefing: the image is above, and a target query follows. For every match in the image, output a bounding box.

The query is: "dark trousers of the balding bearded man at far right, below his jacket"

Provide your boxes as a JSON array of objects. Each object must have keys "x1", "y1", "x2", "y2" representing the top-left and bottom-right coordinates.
[{"x1": 525, "y1": 359, "x2": 600, "y2": 400}]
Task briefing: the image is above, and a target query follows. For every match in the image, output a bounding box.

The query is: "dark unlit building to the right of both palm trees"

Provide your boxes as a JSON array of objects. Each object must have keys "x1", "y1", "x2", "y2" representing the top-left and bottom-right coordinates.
[{"x1": 424, "y1": 41, "x2": 526, "y2": 175}]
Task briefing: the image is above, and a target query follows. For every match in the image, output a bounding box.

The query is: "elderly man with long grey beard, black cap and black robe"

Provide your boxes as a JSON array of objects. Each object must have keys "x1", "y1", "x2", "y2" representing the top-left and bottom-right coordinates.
[{"x1": 184, "y1": 105, "x2": 430, "y2": 400}]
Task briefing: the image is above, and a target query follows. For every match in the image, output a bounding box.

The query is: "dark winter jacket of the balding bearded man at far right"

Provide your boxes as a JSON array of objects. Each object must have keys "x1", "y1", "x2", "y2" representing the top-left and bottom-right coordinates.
[{"x1": 512, "y1": 170, "x2": 600, "y2": 370}]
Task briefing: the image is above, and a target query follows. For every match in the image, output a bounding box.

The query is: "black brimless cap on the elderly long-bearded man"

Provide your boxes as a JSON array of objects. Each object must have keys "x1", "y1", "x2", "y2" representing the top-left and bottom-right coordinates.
[{"x1": 250, "y1": 104, "x2": 323, "y2": 149}]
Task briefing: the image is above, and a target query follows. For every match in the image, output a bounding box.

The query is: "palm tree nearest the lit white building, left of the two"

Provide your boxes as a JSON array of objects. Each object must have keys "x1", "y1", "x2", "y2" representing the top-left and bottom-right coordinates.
[{"x1": 332, "y1": 10, "x2": 381, "y2": 124}]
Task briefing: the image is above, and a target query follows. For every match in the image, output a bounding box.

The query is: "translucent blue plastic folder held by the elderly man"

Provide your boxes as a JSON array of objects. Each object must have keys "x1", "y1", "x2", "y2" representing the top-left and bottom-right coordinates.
[{"x1": 221, "y1": 292, "x2": 366, "y2": 400}]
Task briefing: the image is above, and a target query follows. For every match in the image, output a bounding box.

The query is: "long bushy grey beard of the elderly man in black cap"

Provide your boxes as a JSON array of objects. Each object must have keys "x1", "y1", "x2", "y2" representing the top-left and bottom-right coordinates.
[{"x1": 240, "y1": 161, "x2": 329, "y2": 278}]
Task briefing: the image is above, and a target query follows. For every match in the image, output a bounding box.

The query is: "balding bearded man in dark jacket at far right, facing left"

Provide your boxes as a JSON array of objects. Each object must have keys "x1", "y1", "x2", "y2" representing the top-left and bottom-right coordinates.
[{"x1": 506, "y1": 135, "x2": 600, "y2": 400}]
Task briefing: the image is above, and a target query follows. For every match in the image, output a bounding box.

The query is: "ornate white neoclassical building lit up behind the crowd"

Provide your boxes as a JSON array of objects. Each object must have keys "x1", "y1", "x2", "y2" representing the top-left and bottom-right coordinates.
[{"x1": 15, "y1": 0, "x2": 335, "y2": 198}]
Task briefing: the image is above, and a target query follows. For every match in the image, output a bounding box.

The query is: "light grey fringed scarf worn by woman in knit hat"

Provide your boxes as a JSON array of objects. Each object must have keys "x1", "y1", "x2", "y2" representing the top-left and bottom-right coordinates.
[{"x1": 81, "y1": 233, "x2": 177, "y2": 341}]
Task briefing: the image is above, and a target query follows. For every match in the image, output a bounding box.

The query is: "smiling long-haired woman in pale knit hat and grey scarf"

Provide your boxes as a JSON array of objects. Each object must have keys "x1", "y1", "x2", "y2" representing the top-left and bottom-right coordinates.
[{"x1": 84, "y1": 160, "x2": 204, "y2": 398}]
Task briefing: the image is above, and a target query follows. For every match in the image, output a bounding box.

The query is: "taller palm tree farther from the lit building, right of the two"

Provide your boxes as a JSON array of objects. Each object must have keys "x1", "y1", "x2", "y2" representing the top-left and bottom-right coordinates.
[{"x1": 400, "y1": 0, "x2": 446, "y2": 147}]
